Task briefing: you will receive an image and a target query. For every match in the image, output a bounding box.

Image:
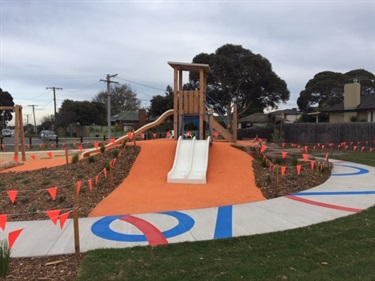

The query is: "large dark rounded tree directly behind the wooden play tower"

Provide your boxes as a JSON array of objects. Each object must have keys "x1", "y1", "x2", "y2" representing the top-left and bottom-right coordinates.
[{"x1": 188, "y1": 44, "x2": 289, "y2": 118}]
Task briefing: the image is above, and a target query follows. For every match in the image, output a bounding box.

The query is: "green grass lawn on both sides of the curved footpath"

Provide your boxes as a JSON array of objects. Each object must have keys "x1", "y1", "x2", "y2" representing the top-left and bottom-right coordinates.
[{"x1": 77, "y1": 152, "x2": 375, "y2": 281}]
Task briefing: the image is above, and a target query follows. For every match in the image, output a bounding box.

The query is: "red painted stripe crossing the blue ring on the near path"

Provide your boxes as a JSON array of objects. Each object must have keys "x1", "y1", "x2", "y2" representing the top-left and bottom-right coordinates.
[{"x1": 120, "y1": 216, "x2": 168, "y2": 246}]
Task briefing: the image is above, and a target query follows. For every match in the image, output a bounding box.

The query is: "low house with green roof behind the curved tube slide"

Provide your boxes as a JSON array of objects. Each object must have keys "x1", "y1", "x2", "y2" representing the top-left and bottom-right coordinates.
[{"x1": 111, "y1": 109, "x2": 147, "y2": 131}]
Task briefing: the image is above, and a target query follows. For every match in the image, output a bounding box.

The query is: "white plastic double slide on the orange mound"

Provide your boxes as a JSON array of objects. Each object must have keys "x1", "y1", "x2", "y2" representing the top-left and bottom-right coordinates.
[{"x1": 167, "y1": 136, "x2": 210, "y2": 184}]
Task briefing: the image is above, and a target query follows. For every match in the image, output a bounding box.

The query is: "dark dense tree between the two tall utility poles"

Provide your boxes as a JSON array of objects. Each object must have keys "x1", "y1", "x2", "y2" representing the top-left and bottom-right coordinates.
[{"x1": 57, "y1": 100, "x2": 107, "y2": 128}]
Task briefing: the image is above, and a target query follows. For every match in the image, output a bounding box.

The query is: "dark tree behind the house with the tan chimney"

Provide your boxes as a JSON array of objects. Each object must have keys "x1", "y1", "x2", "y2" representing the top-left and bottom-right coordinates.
[{"x1": 297, "y1": 69, "x2": 375, "y2": 112}]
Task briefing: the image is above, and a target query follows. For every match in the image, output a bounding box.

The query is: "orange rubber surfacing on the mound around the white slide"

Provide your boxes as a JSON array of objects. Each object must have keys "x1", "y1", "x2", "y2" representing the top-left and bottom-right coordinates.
[{"x1": 89, "y1": 140, "x2": 265, "y2": 217}]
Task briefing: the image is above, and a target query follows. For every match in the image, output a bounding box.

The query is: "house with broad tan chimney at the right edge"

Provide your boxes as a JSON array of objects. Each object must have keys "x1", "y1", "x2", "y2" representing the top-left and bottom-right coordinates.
[{"x1": 324, "y1": 83, "x2": 375, "y2": 123}]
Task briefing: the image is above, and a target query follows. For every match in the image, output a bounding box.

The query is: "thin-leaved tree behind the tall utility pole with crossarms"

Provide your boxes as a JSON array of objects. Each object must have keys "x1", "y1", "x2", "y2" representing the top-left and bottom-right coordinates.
[{"x1": 92, "y1": 84, "x2": 141, "y2": 115}]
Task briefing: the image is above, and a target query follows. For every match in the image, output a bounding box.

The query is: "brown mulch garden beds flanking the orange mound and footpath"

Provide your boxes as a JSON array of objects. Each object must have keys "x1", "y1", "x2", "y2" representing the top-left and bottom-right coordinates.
[{"x1": 0, "y1": 143, "x2": 330, "y2": 281}]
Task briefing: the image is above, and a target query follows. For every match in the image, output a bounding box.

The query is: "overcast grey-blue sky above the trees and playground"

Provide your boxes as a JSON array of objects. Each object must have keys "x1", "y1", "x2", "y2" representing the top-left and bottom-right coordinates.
[{"x1": 0, "y1": 0, "x2": 375, "y2": 123}]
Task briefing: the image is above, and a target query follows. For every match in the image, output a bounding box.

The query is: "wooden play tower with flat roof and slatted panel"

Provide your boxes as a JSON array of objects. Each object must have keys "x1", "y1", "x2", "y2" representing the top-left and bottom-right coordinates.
[{"x1": 168, "y1": 62, "x2": 237, "y2": 142}]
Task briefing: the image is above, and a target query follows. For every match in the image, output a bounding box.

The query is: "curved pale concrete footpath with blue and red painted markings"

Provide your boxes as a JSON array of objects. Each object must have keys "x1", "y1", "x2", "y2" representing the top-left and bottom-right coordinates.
[{"x1": 0, "y1": 161, "x2": 375, "y2": 257}]
